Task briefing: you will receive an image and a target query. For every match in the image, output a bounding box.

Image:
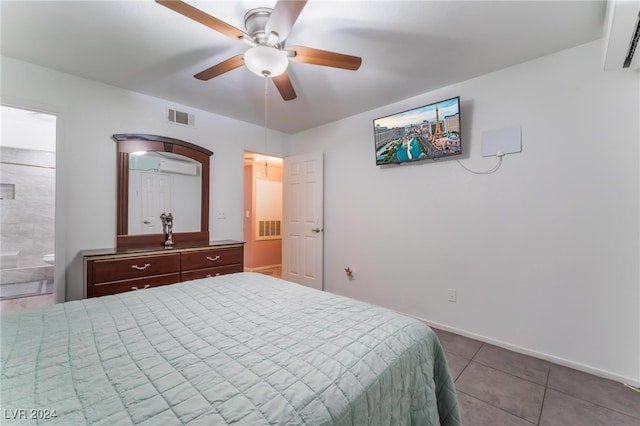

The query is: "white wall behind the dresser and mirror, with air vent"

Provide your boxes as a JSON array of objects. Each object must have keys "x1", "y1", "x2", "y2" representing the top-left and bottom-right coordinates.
[{"x1": 1, "y1": 57, "x2": 290, "y2": 301}]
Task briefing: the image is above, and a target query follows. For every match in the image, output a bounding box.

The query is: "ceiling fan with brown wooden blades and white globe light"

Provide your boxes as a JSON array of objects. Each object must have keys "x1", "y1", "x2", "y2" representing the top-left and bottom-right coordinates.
[{"x1": 156, "y1": 0, "x2": 362, "y2": 101}]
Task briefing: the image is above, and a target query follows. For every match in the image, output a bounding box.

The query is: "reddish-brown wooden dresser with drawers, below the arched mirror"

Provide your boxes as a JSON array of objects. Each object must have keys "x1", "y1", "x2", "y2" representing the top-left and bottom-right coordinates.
[{"x1": 80, "y1": 241, "x2": 244, "y2": 297}]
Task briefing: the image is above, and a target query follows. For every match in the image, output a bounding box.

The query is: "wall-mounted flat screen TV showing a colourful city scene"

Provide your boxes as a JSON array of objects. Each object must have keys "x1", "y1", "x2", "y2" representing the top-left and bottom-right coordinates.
[{"x1": 373, "y1": 97, "x2": 462, "y2": 165}]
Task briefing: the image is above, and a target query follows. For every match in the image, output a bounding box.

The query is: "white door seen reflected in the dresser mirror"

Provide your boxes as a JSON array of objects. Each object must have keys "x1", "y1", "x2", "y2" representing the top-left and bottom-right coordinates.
[{"x1": 140, "y1": 172, "x2": 173, "y2": 234}]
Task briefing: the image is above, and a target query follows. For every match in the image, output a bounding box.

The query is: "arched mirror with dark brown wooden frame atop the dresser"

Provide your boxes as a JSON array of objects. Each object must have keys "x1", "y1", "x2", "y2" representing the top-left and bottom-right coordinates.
[{"x1": 113, "y1": 134, "x2": 213, "y2": 249}]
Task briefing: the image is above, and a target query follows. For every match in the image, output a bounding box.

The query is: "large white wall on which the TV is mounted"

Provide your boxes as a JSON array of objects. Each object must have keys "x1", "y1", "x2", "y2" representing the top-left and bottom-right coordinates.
[{"x1": 293, "y1": 42, "x2": 640, "y2": 384}]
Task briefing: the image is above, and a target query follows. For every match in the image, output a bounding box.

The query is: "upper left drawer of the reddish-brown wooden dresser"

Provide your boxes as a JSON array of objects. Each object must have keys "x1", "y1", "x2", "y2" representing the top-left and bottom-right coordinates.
[{"x1": 93, "y1": 253, "x2": 180, "y2": 284}]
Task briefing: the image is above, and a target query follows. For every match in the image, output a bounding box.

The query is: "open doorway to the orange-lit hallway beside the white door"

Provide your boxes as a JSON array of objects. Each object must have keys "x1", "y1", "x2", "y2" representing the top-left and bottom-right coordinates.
[{"x1": 243, "y1": 151, "x2": 282, "y2": 277}]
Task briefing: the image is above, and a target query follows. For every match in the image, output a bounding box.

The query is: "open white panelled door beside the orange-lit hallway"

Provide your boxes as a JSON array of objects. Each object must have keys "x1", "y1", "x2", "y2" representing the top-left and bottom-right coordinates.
[{"x1": 282, "y1": 152, "x2": 323, "y2": 290}]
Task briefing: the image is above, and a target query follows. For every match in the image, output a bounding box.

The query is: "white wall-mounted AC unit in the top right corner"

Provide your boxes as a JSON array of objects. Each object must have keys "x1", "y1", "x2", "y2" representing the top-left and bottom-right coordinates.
[{"x1": 604, "y1": 0, "x2": 640, "y2": 71}]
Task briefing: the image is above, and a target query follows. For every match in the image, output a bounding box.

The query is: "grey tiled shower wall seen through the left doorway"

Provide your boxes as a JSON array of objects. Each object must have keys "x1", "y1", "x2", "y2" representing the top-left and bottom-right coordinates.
[{"x1": 0, "y1": 147, "x2": 56, "y2": 283}]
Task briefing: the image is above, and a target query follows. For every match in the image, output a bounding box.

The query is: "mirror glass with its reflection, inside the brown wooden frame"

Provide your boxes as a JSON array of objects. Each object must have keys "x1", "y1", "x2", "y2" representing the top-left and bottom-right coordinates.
[{"x1": 129, "y1": 151, "x2": 201, "y2": 235}]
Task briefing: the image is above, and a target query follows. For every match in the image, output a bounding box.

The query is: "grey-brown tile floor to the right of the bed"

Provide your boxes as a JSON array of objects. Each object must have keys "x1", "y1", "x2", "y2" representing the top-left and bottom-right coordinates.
[{"x1": 434, "y1": 329, "x2": 640, "y2": 426}]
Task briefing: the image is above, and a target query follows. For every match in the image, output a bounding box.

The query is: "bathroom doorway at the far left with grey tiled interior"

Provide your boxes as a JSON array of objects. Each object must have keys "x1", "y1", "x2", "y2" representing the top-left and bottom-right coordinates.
[{"x1": 0, "y1": 105, "x2": 56, "y2": 311}]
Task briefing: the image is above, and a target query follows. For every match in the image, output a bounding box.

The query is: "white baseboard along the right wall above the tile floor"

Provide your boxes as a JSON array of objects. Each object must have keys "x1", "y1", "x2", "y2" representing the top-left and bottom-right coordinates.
[{"x1": 413, "y1": 316, "x2": 640, "y2": 387}]
